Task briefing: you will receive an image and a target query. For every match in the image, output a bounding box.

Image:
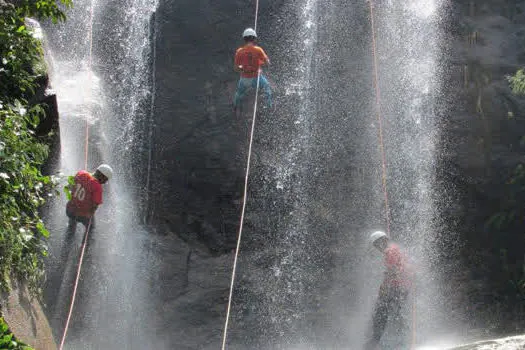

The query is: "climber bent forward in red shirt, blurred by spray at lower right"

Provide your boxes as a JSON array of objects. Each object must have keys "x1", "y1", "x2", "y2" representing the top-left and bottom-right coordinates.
[{"x1": 365, "y1": 231, "x2": 412, "y2": 350}]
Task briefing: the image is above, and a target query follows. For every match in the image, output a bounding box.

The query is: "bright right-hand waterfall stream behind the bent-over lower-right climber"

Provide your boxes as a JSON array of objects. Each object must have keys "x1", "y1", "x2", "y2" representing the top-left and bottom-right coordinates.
[{"x1": 312, "y1": 0, "x2": 450, "y2": 349}]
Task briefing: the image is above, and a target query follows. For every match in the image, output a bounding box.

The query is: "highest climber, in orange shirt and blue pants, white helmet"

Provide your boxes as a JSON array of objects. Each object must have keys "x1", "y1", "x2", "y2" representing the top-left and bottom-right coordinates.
[{"x1": 233, "y1": 28, "x2": 272, "y2": 110}]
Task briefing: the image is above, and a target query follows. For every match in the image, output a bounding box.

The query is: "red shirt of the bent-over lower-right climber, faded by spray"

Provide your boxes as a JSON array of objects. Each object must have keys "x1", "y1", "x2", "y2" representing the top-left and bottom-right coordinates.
[{"x1": 384, "y1": 243, "x2": 411, "y2": 288}]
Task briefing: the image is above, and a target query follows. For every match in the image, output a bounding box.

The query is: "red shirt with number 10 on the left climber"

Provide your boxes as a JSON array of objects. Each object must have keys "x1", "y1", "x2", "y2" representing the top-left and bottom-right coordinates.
[{"x1": 67, "y1": 170, "x2": 102, "y2": 217}]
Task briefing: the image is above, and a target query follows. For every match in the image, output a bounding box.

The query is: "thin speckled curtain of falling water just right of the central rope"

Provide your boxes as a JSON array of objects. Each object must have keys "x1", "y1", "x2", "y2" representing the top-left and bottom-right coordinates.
[{"x1": 229, "y1": 0, "x2": 324, "y2": 349}]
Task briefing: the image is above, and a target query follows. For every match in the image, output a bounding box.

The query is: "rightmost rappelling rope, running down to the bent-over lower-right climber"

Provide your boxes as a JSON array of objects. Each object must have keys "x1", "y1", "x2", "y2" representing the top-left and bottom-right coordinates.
[{"x1": 368, "y1": 0, "x2": 416, "y2": 349}]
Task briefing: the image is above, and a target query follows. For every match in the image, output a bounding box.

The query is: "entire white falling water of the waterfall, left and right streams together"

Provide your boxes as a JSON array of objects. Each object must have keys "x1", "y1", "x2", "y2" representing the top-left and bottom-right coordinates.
[{"x1": 34, "y1": 0, "x2": 482, "y2": 349}]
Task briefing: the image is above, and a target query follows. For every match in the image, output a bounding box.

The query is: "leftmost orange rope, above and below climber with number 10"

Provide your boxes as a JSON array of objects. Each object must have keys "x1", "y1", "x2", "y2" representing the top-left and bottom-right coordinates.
[{"x1": 59, "y1": 0, "x2": 95, "y2": 350}]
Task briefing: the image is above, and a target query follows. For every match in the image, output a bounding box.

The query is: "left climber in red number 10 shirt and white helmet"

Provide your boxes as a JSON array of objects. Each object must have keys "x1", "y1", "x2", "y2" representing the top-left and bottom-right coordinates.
[{"x1": 66, "y1": 164, "x2": 113, "y2": 232}]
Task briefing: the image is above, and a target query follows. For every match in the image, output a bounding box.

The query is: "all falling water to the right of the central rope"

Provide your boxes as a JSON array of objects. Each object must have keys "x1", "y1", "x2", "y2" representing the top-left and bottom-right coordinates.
[{"x1": 221, "y1": 0, "x2": 450, "y2": 349}]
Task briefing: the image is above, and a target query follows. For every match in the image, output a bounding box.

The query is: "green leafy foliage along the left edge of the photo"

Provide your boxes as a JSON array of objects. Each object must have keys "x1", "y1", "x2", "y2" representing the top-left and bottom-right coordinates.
[{"x1": 0, "y1": 0, "x2": 71, "y2": 296}]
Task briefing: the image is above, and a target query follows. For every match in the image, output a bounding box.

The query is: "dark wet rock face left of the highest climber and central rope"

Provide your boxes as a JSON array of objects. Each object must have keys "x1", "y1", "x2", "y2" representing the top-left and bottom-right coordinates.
[{"x1": 150, "y1": 0, "x2": 282, "y2": 252}]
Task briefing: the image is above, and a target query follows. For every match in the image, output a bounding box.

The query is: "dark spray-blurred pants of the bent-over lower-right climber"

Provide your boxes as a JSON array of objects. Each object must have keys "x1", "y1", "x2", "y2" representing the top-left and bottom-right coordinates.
[{"x1": 365, "y1": 287, "x2": 408, "y2": 350}]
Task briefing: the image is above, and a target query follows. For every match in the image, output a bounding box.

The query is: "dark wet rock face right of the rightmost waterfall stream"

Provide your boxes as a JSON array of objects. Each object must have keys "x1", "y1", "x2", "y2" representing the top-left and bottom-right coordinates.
[{"x1": 438, "y1": 0, "x2": 525, "y2": 334}]
